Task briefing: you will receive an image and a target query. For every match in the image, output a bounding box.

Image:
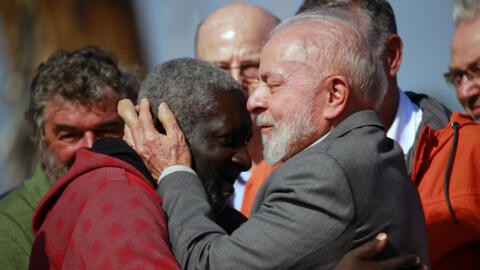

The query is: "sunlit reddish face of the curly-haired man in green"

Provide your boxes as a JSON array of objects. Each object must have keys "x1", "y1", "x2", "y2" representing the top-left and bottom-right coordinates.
[{"x1": 44, "y1": 93, "x2": 123, "y2": 177}]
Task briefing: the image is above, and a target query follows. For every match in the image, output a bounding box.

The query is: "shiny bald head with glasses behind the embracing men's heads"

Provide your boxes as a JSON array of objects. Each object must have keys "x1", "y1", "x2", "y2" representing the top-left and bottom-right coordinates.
[{"x1": 195, "y1": 2, "x2": 280, "y2": 91}]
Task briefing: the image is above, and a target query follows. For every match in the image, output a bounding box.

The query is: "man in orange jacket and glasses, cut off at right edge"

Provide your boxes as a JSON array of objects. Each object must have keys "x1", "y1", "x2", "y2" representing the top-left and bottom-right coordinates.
[{"x1": 404, "y1": 0, "x2": 480, "y2": 270}]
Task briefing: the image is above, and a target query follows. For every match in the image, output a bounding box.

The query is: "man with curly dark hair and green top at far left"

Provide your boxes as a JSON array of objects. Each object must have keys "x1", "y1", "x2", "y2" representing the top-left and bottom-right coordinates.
[{"x1": 0, "y1": 46, "x2": 138, "y2": 269}]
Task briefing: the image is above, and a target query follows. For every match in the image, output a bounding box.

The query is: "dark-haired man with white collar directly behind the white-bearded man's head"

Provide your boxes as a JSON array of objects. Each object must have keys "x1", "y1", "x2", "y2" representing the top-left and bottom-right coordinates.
[{"x1": 297, "y1": 0, "x2": 451, "y2": 174}]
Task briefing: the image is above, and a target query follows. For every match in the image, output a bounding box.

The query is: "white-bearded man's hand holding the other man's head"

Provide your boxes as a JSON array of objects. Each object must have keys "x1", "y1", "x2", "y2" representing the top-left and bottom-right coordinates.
[{"x1": 118, "y1": 99, "x2": 191, "y2": 179}]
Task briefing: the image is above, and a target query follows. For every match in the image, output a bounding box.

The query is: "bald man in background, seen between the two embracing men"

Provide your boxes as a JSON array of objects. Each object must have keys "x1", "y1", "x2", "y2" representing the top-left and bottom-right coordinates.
[{"x1": 195, "y1": 2, "x2": 280, "y2": 217}]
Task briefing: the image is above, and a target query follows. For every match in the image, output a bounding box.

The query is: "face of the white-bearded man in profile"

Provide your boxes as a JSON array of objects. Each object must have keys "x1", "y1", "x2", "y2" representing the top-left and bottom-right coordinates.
[{"x1": 247, "y1": 27, "x2": 328, "y2": 164}]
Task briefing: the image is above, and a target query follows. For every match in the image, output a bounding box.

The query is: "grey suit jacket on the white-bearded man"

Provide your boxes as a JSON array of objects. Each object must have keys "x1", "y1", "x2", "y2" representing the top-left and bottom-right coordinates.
[{"x1": 157, "y1": 111, "x2": 429, "y2": 269}]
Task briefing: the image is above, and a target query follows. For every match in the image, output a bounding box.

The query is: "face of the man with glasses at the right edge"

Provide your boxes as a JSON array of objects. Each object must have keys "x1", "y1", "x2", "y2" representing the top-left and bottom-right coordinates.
[{"x1": 450, "y1": 16, "x2": 480, "y2": 122}]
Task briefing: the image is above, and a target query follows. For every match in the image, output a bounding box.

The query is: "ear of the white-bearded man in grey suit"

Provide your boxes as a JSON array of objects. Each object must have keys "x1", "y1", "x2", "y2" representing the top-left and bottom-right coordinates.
[{"x1": 324, "y1": 75, "x2": 351, "y2": 120}]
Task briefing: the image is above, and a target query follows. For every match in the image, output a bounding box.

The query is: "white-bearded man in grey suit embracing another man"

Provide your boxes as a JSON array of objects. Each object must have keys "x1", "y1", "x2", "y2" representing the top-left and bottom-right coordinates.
[{"x1": 121, "y1": 8, "x2": 429, "y2": 269}]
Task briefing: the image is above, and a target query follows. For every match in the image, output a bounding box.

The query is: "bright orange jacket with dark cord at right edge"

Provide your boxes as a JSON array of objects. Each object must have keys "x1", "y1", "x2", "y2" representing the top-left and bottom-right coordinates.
[{"x1": 412, "y1": 112, "x2": 480, "y2": 269}]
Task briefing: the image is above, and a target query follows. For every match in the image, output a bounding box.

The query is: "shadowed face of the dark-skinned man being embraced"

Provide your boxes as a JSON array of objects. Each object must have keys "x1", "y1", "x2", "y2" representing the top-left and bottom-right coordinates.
[{"x1": 189, "y1": 93, "x2": 252, "y2": 213}]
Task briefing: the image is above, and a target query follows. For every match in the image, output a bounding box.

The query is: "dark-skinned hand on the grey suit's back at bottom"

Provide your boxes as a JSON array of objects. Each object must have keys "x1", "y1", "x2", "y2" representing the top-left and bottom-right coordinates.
[{"x1": 334, "y1": 233, "x2": 427, "y2": 270}]
